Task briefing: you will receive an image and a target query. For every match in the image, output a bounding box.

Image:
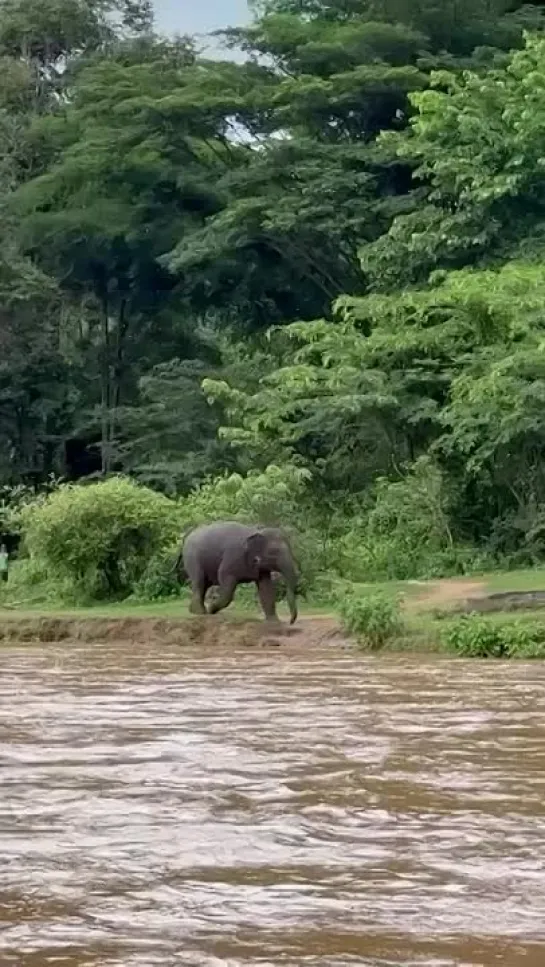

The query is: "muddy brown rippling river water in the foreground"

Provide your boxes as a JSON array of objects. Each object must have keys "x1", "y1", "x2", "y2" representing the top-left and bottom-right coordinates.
[{"x1": 0, "y1": 643, "x2": 545, "y2": 967}]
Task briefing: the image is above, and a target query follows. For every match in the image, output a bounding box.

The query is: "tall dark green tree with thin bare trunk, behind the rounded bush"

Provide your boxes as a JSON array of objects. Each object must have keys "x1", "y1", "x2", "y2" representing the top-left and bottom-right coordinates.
[{"x1": 14, "y1": 39, "x2": 230, "y2": 472}]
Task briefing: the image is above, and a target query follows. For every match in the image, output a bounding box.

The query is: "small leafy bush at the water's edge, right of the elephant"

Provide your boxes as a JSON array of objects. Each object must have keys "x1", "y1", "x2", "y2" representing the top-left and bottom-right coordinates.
[{"x1": 337, "y1": 588, "x2": 403, "y2": 650}]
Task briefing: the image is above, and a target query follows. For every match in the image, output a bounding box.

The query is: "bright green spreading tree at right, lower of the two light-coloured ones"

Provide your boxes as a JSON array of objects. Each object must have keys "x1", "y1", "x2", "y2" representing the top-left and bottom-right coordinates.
[{"x1": 205, "y1": 262, "x2": 545, "y2": 552}]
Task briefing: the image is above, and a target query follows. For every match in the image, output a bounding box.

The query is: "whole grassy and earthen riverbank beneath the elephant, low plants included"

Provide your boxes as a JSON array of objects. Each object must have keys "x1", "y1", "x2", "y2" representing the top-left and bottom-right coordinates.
[{"x1": 0, "y1": 569, "x2": 545, "y2": 657}]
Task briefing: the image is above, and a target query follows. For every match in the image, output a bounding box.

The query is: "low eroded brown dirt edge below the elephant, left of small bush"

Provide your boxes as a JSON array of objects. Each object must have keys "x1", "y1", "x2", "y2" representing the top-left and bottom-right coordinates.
[{"x1": 0, "y1": 614, "x2": 347, "y2": 647}]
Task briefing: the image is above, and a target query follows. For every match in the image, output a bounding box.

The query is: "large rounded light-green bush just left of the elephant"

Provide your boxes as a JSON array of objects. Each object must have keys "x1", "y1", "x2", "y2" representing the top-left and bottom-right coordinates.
[{"x1": 21, "y1": 477, "x2": 180, "y2": 600}]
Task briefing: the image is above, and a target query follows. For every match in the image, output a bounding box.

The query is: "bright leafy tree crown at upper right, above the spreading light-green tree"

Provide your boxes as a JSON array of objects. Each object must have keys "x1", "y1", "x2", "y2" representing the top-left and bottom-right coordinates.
[{"x1": 364, "y1": 36, "x2": 545, "y2": 287}]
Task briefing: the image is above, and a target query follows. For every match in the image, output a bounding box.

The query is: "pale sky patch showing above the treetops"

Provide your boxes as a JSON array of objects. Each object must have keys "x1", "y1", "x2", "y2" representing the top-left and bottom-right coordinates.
[{"x1": 155, "y1": 0, "x2": 249, "y2": 34}]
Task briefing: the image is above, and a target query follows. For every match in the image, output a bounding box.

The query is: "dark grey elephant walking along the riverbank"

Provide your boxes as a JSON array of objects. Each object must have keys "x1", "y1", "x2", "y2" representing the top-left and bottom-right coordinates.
[{"x1": 177, "y1": 521, "x2": 299, "y2": 624}]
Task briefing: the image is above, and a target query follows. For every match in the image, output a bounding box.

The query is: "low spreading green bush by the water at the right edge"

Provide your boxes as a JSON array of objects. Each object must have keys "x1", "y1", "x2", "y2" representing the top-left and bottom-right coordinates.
[{"x1": 441, "y1": 614, "x2": 545, "y2": 658}]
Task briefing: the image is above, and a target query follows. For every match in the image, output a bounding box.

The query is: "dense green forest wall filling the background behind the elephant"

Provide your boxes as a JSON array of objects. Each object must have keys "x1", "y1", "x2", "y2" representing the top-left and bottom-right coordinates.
[{"x1": 4, "y1": 0, "x2": 545, "y2": 596}]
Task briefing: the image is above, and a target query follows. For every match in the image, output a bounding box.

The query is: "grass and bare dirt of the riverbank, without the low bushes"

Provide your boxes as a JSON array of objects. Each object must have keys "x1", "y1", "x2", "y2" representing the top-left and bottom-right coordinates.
[{"x1": 0, "y1": 569, "x2": 545, "y2": 652}]
